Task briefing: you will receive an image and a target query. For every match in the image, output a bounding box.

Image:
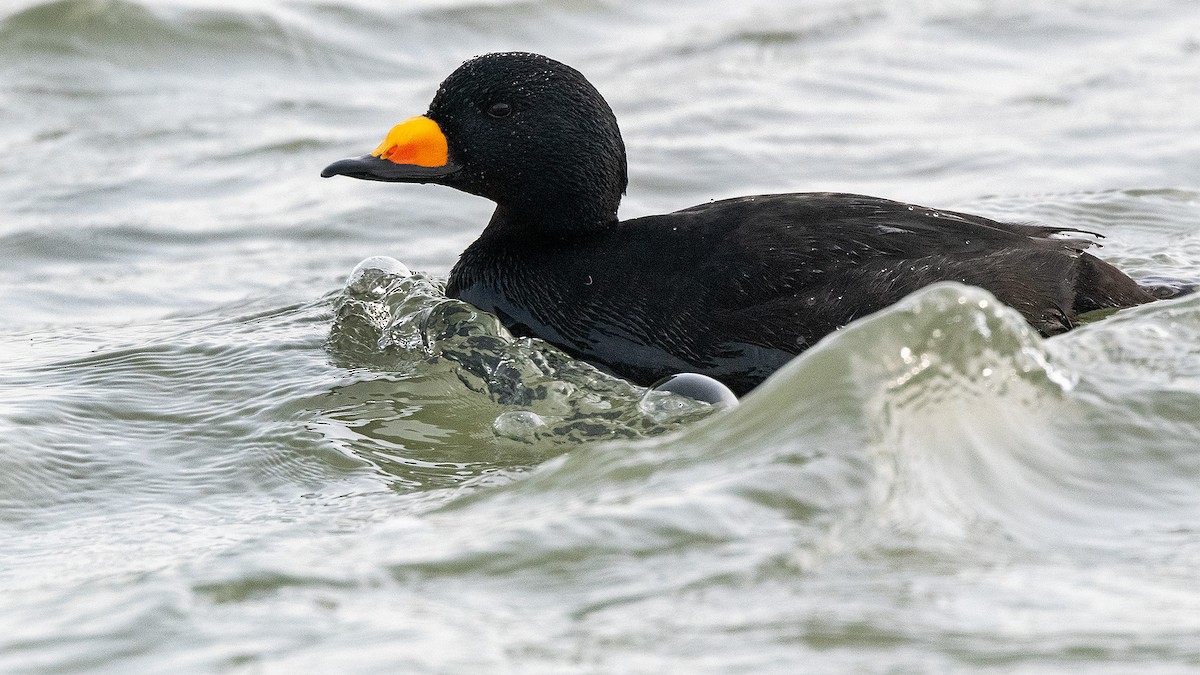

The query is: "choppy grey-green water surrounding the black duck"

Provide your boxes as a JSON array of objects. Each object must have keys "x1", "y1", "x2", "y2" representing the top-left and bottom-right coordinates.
[{"x1": 0, "y1": 0, "x2": 1200, "y2": 673}]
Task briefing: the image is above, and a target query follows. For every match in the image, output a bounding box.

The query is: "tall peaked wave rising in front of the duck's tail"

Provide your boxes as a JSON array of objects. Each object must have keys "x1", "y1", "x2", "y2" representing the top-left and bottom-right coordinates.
[{"x1": 333, "y1": 283, "x2": 1200, "y2": 581}]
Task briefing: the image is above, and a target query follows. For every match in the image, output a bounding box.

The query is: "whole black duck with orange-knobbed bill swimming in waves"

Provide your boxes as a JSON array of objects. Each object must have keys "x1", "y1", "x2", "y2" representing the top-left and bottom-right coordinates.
[{"x1": 322, "y1": 52, "x2": 1156, "y2": 395}]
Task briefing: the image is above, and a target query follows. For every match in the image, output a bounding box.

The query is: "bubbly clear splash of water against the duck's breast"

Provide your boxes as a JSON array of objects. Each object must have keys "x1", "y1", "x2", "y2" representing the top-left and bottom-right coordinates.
[{"x1": 328, "y1": 257, "x2": 716, "y2": 444}]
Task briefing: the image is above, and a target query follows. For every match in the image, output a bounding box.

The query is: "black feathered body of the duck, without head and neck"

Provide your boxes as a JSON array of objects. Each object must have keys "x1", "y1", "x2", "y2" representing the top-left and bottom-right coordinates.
[{"x1": 449, "y1": 193, "x2": 1146, "y2": 393}]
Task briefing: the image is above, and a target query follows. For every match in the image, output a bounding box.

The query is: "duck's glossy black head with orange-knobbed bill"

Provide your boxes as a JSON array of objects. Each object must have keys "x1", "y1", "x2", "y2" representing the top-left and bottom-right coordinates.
[{"x1": 322, "y1": 52, "x2": 626, "y2": 234}]
